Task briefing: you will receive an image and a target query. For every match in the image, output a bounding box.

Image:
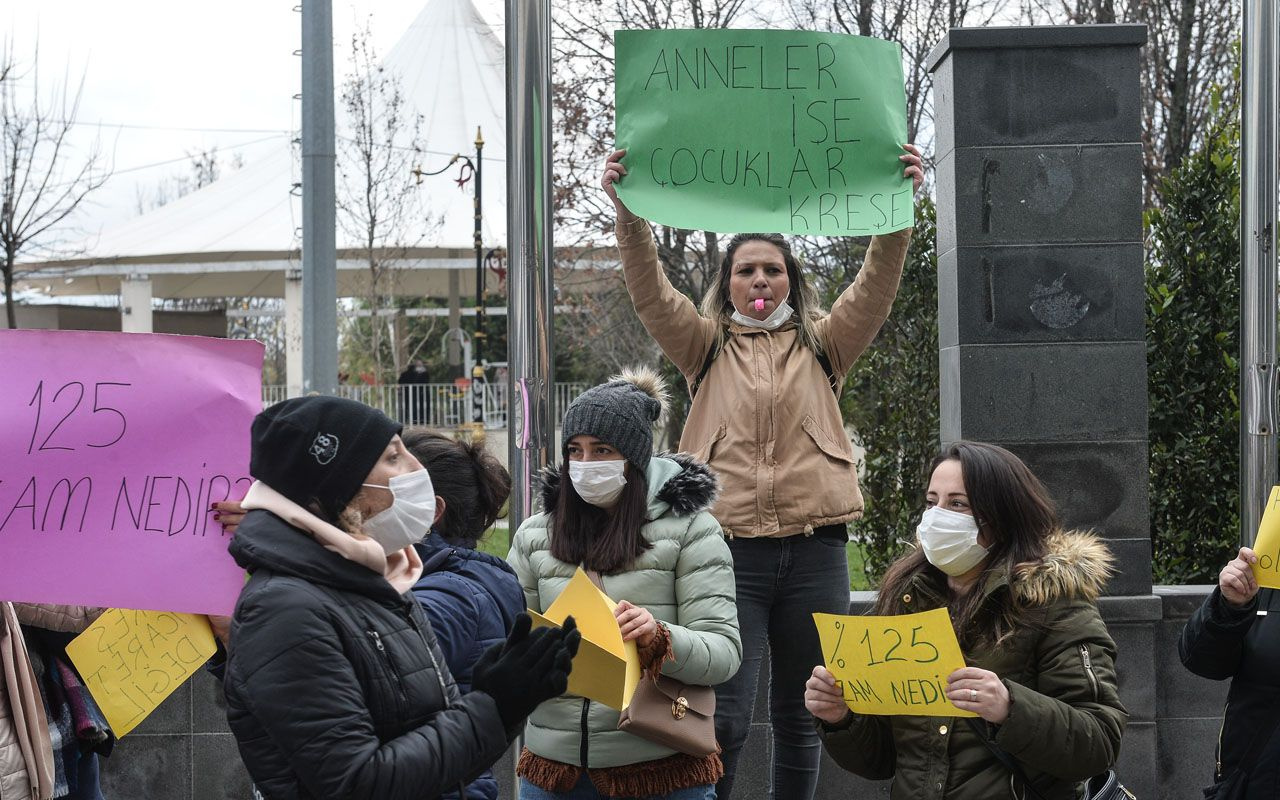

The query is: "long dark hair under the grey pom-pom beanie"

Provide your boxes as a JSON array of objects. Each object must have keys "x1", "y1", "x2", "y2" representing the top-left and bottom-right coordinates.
[{"x1": 550, "y1": 456, "x2": 653, "y2": 575}]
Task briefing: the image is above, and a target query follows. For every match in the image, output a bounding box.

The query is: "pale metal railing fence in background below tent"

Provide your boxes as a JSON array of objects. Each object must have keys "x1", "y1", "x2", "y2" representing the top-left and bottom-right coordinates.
[{"x1": 262, "y1": 381, "x2": 590, "y2": 430}]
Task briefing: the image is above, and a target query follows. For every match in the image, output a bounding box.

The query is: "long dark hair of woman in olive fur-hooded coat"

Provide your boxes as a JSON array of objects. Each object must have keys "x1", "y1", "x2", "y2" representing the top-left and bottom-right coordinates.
[{"x1": 876, "y1": 442, "x2": 1059, "y2": 648}]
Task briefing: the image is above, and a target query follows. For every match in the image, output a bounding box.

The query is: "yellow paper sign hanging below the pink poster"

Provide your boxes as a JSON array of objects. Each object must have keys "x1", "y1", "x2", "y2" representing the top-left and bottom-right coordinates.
[{"x1": 67, "y1": 608, "x2": 218, "y2": 739}]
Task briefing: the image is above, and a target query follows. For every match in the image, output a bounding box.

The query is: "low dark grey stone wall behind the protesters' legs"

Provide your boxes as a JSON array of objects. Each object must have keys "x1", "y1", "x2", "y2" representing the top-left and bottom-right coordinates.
[{"x1": 102, "y1": 586, "x2": 1226, "y2": 800}]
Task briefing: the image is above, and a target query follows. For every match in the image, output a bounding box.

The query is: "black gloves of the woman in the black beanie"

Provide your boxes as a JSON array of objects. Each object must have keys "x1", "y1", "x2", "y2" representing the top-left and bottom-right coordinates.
[{"x1": 471, "y1": 614, "x2": 582, "y2": 730}]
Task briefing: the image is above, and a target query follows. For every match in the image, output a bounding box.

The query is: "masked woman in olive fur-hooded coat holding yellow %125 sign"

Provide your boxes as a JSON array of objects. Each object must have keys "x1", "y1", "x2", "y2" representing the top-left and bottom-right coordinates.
[{"x1": 805, "y1": 442, "x2": 1132, "y2": 800}]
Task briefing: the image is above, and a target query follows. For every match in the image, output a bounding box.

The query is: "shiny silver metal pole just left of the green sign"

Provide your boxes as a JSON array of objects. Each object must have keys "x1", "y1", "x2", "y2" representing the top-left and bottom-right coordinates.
[{"x1": 507, "y1": 0, "x2": 556, "y2": 530}]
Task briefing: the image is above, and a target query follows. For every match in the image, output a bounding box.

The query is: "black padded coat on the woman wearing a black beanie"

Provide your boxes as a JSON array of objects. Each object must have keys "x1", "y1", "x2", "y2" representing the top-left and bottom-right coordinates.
[{"x1": 224, "y1": 511, "x2": 509, "y2": 800}]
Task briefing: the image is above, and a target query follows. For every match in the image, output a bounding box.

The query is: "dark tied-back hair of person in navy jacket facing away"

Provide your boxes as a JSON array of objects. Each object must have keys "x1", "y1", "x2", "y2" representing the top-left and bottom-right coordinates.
[{"x1": 401, "y1": 428, "x2": 511, "y2": 549}]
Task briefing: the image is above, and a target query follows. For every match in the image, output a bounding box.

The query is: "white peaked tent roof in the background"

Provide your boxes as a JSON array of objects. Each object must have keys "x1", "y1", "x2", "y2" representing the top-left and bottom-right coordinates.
[{"x1": 22, "y1": 0, "x2": 507, "y2": 297}]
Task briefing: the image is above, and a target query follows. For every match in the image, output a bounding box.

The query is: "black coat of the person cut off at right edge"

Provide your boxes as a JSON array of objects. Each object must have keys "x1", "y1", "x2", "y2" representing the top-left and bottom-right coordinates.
[{"x1": 1178, "y1": 589, "x2": 1280, "y2": 800}]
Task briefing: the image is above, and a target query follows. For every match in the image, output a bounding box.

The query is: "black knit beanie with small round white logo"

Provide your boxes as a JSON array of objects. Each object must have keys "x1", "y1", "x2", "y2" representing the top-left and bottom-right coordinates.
[{"x1": 248, "y1": 396, "x2": 401, "y2": 520}]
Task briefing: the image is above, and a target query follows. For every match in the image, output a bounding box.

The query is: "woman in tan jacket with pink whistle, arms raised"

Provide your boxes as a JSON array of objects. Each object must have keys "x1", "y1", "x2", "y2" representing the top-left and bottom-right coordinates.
[{"x1": 602, "y1": 145, "x2": 924, "y2": 800}]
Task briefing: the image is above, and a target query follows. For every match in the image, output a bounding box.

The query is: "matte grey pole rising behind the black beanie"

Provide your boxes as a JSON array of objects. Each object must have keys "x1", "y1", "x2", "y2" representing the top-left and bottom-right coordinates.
[{"x1": 302, "y1": 0, "x2": 338, "y2": 394}]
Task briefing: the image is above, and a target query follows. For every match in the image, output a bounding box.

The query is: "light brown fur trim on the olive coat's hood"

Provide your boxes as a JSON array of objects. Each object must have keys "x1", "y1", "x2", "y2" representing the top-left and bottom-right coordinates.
[{"x1": 1009, "y1": 530, "x2": 1115, "y2": 605}]
